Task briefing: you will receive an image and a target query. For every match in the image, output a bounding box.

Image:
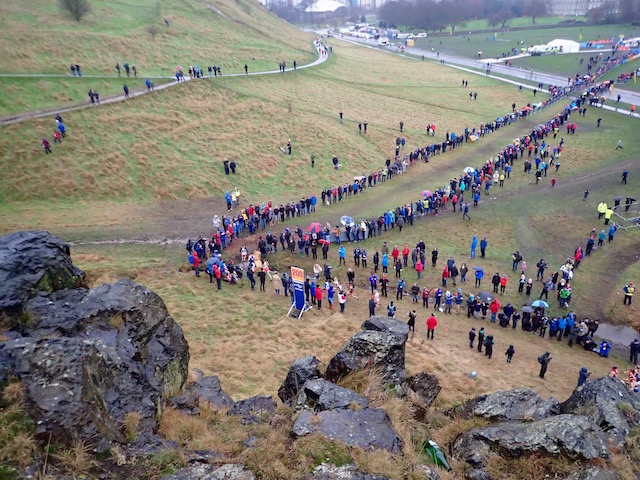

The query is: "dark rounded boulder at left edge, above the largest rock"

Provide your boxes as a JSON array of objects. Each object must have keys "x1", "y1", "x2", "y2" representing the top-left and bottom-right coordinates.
[{"x1": 0, "y1": 231, "x2": 87, "y2": 318}]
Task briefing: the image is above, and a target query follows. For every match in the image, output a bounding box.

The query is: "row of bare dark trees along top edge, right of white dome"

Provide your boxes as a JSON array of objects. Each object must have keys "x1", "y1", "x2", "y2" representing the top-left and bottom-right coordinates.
[{"x1": 378, "y1": 0, "x2": 549, "y2": 32}]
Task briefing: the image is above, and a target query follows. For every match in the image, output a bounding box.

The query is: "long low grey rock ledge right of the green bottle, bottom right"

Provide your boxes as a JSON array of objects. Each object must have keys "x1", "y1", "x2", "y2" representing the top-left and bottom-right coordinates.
[{"x1": 453, "y1": 415, "x2": 609, "y2": 478}]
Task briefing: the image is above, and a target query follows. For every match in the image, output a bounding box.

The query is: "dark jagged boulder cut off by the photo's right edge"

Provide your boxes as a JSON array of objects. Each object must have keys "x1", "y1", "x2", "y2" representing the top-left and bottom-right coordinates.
[{"x1": 560, "y1": 377, "x2": 640, "y2": 446}]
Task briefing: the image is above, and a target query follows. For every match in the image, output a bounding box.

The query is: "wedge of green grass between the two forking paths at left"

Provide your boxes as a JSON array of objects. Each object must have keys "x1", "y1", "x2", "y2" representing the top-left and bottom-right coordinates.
[{"x1": 0, "y1": 77, "x2": 171, "y2": 117}]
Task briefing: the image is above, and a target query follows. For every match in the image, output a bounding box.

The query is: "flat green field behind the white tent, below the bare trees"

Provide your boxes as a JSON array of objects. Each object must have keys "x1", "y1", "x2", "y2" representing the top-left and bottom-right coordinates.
[{"x1": 416, "y1": 25, "x2": 640, "y2": 59}]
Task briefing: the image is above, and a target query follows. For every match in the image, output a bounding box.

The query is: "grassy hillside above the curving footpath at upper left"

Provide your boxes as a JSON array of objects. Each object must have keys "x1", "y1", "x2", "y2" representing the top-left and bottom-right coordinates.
[{"x1": 0, "y1": 0, "x2": 312, "y2": 75}]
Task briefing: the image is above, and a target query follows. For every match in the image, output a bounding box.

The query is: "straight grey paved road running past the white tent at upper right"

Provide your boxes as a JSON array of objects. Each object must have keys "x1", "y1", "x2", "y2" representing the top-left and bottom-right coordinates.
[{"x1": 342, "y1": 37, "x2": 640, "y2": 110}]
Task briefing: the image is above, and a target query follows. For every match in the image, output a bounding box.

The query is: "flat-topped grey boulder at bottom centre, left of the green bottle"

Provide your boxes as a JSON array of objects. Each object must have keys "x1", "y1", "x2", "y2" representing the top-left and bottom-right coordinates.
[{"x1": 292, "y1": 408, "x2": 402, "y2": 453}]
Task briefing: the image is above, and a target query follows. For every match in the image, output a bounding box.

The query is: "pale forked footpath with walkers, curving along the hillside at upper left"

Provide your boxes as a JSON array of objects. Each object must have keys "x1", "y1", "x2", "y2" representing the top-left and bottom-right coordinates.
[{"x1": 0, "y1": 45, "x2": 328, "y2": 125}]
